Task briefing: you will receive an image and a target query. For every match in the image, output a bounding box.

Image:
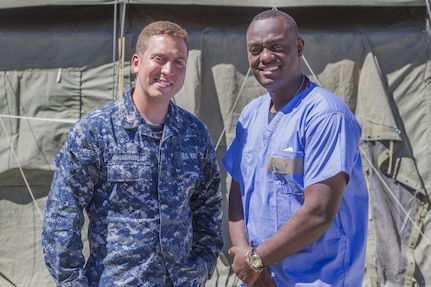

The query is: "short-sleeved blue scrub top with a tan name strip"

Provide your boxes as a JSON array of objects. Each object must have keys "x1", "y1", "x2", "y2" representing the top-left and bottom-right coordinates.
[{"x1": 223, "y1": 82, "x2": 368, "y2": 287}]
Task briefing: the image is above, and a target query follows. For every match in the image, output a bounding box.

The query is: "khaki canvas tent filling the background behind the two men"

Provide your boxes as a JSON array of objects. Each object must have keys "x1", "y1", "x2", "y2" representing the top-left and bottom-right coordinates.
[{"x1": 0, "y1": 0, "x2": 431, "y2": 287}]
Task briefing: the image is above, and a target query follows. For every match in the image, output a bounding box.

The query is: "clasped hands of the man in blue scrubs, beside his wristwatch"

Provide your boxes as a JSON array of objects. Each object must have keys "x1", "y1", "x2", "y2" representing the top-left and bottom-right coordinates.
[{"x1": 228, "y1": 246, "x2": 262, "y2": 287}]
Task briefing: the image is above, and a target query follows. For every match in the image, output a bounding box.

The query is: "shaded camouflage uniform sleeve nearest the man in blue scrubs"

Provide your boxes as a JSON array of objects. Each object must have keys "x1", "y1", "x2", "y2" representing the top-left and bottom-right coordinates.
[{"x1": 191, "y1": 136, "x2": 223, "y2": 278}]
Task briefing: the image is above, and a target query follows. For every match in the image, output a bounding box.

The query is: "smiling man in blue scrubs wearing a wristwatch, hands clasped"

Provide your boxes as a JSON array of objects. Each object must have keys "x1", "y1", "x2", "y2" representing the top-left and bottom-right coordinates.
[{"x1": 223, "y1": 10, "x2": 368, "y2": 287}]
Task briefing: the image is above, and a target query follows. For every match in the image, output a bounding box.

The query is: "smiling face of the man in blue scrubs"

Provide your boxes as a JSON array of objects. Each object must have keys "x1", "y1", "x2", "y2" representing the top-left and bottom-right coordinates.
[{"x1": 246, "y1": 16, "x2": 304, "y2": 94}]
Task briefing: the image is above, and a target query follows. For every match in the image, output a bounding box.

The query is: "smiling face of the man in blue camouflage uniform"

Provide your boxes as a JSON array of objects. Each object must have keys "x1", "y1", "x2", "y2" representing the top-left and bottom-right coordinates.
[{"x1": 132, "y1": 34, "x2": 188, "y2": 103}]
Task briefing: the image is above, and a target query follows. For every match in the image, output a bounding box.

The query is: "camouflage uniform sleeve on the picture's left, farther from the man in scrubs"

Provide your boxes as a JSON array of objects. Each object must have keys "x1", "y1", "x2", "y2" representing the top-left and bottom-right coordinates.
[{"x1": 42, "y1": 124, "x2": 99, "y2": 287}]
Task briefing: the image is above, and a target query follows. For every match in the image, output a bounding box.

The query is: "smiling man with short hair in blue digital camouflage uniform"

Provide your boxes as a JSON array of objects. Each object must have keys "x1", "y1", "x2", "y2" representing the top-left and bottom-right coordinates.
[{"x1": 42, "y1": 21, "x2": 223, "y2": 287}]
